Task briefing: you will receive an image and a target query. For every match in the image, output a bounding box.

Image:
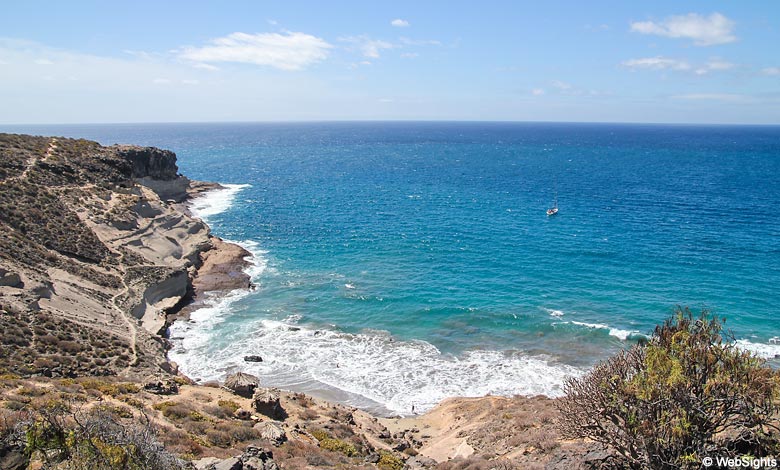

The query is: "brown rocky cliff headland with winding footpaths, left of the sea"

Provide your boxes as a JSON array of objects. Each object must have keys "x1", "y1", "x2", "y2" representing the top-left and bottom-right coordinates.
[{"x1": 0, "y1": 134, "x2": 247, "y2": 377}]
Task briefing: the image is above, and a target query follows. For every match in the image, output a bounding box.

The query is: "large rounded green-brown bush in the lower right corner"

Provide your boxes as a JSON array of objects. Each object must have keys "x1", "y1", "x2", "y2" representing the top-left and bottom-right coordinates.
[{"x1": 558, "y1": 308, "x2": 780, "y2": 469}]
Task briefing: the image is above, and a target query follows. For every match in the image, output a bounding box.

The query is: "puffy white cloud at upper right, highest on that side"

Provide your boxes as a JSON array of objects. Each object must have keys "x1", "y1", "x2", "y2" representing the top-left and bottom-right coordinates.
[{"x1": 631, "y1": 13, "x2": 737, "y2": 46}]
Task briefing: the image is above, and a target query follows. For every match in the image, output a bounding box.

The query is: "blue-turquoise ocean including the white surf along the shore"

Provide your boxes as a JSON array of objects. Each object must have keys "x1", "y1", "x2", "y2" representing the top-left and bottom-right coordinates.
[{"x1": 0, "y1": 122, "x2": 780, "y2": 414}]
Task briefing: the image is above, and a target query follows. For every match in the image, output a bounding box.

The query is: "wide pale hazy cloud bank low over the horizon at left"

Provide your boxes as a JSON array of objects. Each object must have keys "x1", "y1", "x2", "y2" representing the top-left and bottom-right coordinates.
[{"x1": 0, "y1": 38, "x2": 344, "y2": 123}]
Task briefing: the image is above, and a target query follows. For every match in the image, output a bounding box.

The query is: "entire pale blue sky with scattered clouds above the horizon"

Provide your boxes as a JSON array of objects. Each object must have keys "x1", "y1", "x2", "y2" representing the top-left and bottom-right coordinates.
[{"x1": 0, "y1": 0, "x2": 780, "y2": 124}]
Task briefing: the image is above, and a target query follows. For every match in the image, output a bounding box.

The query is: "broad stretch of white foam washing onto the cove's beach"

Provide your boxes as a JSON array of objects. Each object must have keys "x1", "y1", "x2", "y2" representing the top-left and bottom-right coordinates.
[{"x1": 170, "y1": 316, "x2": 582, "y2": 414}]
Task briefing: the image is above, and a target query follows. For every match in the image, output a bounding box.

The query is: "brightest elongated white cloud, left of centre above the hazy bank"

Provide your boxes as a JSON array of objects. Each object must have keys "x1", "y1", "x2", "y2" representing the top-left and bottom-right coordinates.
[{"x1": 179, "y1": 31, "x2": 333, "y2": 70}]
